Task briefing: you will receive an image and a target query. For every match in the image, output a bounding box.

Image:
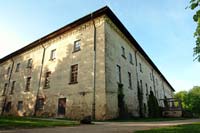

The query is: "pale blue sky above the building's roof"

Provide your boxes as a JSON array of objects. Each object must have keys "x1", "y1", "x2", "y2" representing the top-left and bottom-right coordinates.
[{"x1": 0, "y1": 0, "x2": 200, "y2": 91}]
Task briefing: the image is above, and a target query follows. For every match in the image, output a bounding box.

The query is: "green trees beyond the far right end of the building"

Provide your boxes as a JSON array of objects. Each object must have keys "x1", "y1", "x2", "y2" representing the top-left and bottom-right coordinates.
[{"x1": 175, "y1": 86, "x2": 200, "y2": 116}]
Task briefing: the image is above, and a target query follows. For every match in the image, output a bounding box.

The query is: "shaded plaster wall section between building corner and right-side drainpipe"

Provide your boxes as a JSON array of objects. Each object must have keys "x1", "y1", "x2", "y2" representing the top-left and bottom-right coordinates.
[{"x1": 105, "y1": 18, "x2": 138, "y2": 118}]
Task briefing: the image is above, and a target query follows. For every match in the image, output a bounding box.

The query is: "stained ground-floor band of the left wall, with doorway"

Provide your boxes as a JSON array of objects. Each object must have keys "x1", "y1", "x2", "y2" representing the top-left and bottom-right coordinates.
[{"x1": 0, "y1": 92, "x2": 106, "y2": 120}]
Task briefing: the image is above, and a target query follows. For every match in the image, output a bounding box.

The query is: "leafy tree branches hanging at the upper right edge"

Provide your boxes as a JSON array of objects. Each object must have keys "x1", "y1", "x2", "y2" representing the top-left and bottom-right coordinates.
[{"x1": 189, "y1": 0, "x2": 200, "y2": 62}]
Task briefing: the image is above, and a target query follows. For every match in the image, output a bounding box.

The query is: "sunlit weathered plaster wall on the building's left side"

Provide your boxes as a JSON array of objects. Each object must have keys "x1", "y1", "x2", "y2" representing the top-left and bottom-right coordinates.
[{"x1": 0, "y1": 17, "x2": 106, "y2": 119}]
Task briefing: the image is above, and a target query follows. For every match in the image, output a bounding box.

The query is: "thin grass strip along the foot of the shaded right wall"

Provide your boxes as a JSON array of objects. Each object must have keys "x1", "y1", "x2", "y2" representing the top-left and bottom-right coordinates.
[{"x1": 96, "y1": 118, "x2": 189, "y2": 122}]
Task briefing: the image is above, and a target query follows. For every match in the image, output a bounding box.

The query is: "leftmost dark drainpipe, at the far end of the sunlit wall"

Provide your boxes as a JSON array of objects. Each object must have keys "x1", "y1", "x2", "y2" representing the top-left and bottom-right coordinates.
[{"x1": 1, "y1": 58, "x2": 14, "y2": 115}]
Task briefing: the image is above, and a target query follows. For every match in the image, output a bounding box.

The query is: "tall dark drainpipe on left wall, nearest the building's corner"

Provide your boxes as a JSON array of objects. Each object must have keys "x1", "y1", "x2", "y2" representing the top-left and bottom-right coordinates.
[{"x1": 91, "y1": 13, "x2": 96, "y2": 120}]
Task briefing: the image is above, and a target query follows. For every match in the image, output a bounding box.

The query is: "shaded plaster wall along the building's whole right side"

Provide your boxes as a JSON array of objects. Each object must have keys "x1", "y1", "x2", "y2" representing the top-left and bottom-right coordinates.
[{"x1": 105, "y1": 15, "x2": 173, "y2": 118}]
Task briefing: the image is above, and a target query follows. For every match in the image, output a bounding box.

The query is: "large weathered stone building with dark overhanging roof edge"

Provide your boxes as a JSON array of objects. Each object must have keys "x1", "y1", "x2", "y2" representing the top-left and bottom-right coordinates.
[{"x1": 0, "y1": 7, "x2": 174, "y2": 120}]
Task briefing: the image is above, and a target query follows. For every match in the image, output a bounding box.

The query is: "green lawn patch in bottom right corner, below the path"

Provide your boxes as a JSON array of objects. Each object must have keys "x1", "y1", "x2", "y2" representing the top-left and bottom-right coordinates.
[{"x1": 136, "y1": 122, "x2": 200, "y2": 133}]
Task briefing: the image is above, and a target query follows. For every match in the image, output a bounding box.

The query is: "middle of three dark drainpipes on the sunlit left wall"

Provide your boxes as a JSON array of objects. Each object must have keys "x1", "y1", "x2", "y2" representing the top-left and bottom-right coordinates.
[{"x1": 33, "y1": 44, "x2": 46, "y2": 116}]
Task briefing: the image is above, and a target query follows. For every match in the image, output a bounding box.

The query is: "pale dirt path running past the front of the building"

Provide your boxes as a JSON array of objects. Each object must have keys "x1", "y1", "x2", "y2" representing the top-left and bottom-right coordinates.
[{"x1": 0, "y1": 119, "x2": 200, "y2": 133}]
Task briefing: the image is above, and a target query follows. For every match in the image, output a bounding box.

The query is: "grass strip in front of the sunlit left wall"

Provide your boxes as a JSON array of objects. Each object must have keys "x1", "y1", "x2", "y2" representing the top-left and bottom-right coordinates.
[{"x1": 0, "y1": 117, "x2": 79, "y2": 129}]
